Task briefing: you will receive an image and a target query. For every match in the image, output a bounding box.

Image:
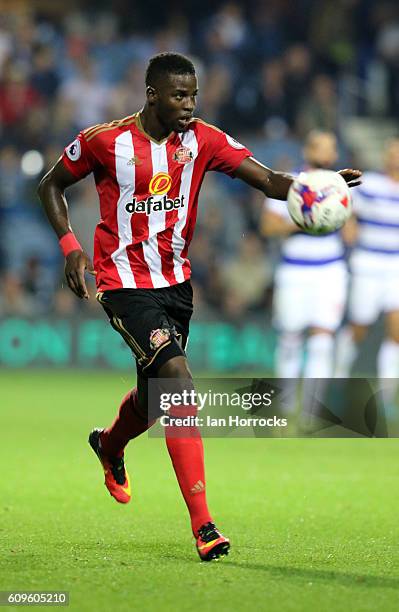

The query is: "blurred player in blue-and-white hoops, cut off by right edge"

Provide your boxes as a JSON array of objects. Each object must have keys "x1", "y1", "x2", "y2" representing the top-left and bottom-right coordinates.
[{"x1": 336, "y1": 138, "x2": 399, "y2": 407}]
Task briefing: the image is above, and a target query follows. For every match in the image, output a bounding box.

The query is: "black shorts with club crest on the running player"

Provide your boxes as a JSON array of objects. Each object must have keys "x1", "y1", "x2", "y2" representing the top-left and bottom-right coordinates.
[{"x1": 97, "y1": 281, "x2": 193, "y2": 378}]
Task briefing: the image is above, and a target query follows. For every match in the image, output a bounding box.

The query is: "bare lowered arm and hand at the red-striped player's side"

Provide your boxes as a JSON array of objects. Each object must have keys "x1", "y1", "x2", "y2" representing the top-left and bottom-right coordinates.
[{"x1": 38, "y1": 160, "x2": 94, "y2": 299}]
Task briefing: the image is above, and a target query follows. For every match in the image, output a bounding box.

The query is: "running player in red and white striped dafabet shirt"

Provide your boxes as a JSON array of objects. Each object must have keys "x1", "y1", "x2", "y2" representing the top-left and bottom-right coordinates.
[{"x1": 39, "y1": 53, "x2": 361, "y2": 561}]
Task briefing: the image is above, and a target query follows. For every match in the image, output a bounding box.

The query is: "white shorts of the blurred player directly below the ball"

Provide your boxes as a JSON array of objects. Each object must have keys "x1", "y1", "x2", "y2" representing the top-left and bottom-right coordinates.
[{"x1": 273, "y1": 261, "x2": 348, "y2": 332}]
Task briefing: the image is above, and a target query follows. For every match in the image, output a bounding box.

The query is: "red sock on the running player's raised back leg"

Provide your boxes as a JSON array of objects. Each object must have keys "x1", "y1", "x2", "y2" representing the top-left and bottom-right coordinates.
[{"x1": 100, "y1": 389, "x2": 155, "y2": 457}]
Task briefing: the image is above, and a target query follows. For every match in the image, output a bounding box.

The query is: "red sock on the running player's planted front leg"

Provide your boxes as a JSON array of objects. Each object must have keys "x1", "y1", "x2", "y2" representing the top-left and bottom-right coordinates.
[{"x1": 165, "y1": 408, "x2": 212, "y2": 537}]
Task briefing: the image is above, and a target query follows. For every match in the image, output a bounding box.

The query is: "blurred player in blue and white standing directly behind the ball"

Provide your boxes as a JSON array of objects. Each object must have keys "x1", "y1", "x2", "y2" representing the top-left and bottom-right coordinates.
[{"x1": 262, "y1": 131, "x2": 347, "y2": 409}]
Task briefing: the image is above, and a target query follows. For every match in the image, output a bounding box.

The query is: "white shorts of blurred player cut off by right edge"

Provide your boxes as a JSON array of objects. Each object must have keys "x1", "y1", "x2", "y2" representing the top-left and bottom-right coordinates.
[{"x1": 348, "y1": 251, "x2": 399, "y2": 325}]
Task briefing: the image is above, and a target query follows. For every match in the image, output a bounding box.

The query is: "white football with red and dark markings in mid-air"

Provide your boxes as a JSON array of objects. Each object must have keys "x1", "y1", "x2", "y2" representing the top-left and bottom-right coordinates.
[{"x1": 287, "y1": 170, "x2": 352, "y2": 236}]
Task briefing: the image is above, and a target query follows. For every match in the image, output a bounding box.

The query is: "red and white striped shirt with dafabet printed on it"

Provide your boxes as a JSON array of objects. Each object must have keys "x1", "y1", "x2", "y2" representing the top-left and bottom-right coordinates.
[{"x1": 62, "y1": 113, "x2": 252, "y2": 291}]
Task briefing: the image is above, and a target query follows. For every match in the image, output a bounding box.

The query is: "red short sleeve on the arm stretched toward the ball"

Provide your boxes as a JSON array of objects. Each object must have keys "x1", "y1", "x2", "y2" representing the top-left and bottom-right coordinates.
[{"x1": 207, "y1": 129, "x2": 252, "y2": 176}]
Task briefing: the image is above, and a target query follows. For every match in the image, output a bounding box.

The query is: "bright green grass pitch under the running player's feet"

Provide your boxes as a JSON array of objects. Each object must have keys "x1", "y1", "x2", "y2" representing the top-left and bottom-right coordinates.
[{"x1": 0, "y1": 372, "x2": 399, "y2": 612}]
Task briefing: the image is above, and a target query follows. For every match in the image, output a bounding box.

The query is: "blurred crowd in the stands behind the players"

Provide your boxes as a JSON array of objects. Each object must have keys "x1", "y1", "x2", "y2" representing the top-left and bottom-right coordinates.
[{"x1": 0, "y1": 0, "x2": 399, "y2": 320}]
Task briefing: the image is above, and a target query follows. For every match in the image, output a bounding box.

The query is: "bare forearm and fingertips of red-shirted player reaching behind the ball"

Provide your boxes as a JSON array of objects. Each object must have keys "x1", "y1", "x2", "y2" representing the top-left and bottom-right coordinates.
[{"x1": 234, "y1": 157, "x2": 362, "y2": 200}]
